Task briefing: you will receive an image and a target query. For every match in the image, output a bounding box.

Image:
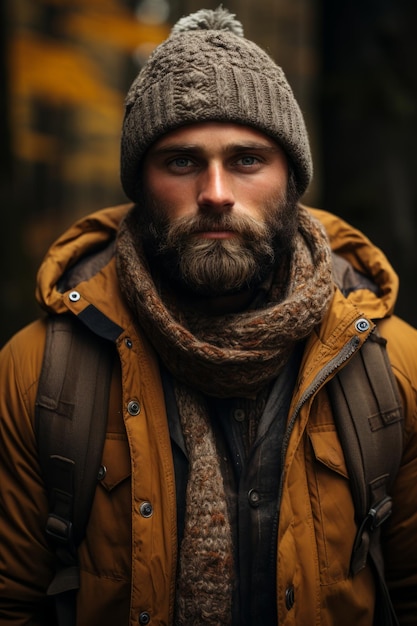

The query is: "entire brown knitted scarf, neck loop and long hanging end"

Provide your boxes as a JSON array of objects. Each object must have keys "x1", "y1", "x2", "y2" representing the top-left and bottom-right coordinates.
[{"x1": 116, "y1": 207, "x2": 333, "y2": 626}]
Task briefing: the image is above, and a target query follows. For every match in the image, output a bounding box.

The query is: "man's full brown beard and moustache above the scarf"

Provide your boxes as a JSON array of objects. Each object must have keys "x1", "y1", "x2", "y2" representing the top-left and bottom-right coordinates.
[{"x1": 138, "y1": 178, "x2": 298, "y2": 297}]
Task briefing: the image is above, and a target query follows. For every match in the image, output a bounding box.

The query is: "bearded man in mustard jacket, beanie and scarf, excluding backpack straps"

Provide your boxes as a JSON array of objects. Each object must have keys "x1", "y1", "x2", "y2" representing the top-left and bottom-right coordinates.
[{"x1": 0, "y1": 8, "x2": 417, "y2": 626}]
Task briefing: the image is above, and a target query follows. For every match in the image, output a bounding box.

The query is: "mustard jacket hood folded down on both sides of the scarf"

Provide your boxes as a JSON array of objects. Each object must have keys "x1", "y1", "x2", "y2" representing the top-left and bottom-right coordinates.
[{"x1": 36, "y1": 204, "x2": 399, "y2": 319}]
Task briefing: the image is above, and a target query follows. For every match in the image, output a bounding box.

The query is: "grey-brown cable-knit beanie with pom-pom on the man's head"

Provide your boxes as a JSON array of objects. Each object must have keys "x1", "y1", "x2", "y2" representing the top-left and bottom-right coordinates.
[{"x1": 121, "y1": 7, "x2": 313, "y2": 201}]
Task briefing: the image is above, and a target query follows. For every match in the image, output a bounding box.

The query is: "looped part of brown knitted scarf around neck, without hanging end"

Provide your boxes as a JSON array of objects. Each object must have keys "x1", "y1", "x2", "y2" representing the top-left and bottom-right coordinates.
[{"x1": 117, "y1": 207, "x2": 333, "y2": 397}]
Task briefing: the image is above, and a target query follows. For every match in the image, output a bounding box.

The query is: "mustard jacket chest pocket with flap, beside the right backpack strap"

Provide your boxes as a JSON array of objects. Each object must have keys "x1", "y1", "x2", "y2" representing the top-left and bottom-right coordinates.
[{"x1": 306, "y1": 425, "x2": 356, "y2": 584}]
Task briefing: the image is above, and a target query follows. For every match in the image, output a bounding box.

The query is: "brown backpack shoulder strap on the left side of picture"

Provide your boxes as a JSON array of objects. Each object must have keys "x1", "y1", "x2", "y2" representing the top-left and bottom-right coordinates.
[{"x1": 35, "y1": 315, "x2": 113, "y2": 624}]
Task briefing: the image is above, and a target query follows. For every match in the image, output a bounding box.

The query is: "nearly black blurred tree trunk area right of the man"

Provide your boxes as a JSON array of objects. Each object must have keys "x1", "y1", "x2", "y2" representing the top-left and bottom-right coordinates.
[{"x1": 322, "y1": 0, "x2": 417, "y2": 325}]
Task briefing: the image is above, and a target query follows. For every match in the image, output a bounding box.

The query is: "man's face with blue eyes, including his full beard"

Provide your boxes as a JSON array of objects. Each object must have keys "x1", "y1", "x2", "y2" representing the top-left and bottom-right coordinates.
[{"x1": 138, "y1": 122, "x2": 297, "y2": 296}]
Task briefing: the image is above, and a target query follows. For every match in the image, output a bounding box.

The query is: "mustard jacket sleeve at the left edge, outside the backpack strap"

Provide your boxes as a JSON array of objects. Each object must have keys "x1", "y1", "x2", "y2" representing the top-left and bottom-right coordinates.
[{"x1": 0, "y1": 321, "x2": 55, "y2": 626}]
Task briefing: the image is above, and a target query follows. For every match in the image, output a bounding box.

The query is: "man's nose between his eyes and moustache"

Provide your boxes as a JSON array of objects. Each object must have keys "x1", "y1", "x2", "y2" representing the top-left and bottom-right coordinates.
[{"x1": 197, "y1": 163, "x2": 235, "y2": 211}]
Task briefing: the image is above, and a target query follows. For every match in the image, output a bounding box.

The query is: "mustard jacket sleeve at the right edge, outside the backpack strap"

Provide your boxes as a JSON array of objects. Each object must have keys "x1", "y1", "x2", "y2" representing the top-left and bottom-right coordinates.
[{"x1": 382, "y1": 318, "x2": 417, "y2": 626}]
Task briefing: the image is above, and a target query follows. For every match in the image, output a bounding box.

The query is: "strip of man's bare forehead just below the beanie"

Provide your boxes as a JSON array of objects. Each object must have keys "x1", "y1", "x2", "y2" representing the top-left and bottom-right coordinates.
[{"x1": 149, "y1": 122, "x2": 278, "y2": 153}]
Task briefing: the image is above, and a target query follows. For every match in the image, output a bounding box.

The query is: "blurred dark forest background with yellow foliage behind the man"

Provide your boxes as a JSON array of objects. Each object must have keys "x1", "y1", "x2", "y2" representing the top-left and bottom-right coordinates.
[{"x1": 0, "y1": 0, "x2": 417, "y2": 345}]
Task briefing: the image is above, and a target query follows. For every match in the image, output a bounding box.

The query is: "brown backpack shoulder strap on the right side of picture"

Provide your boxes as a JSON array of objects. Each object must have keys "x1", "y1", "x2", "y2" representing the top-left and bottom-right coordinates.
[{"x1": 328, "y1": 329, "x2": 403, "y2": 626}]
